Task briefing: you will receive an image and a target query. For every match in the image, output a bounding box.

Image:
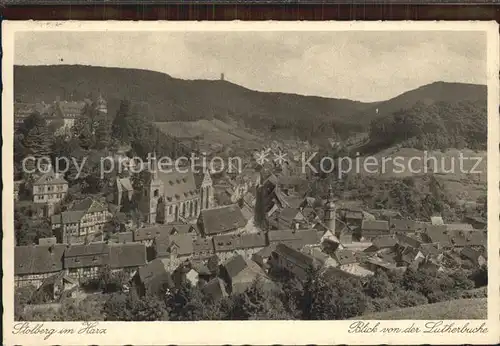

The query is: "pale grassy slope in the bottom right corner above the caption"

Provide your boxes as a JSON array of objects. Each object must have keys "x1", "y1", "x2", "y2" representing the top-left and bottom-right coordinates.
[{"x1": 353, "y1": 298, "x2": 488, "y2": 320}]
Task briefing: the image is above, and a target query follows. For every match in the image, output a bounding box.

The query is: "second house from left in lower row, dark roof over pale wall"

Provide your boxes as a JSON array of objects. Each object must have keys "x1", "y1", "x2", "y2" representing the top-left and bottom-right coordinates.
[{"x1": 64, "y1": 242, "x2": 109, "y2": 282}]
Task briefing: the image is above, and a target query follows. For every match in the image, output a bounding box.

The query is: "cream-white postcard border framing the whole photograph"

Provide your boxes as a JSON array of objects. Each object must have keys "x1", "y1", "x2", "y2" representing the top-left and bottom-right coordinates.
[{"x1": 2, "y1": 21, "x2": 500, "y2": 345}]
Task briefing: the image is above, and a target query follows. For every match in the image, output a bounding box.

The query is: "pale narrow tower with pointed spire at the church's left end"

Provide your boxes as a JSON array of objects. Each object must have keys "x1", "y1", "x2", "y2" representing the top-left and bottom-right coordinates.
[{"x1": 141, "y1": 153, "x2": 164, "y2": 224}]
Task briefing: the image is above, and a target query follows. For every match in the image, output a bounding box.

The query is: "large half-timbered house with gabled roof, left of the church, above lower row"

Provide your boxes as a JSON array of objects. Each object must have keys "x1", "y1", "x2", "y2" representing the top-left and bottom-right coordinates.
[{"x1": 51, "y1": 198, "x2": 112, "y2": 244}]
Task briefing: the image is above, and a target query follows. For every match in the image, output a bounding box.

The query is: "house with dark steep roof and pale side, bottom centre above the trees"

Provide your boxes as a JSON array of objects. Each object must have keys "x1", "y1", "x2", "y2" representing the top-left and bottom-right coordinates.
[{"x1": 221, "y1": 255, "x2": 271, "y2": 294}]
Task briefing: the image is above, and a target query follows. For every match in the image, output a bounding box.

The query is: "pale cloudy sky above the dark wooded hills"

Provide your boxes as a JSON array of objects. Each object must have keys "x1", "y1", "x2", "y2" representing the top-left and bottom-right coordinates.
[{"x1": 15, "y1": 31, "x2": 487, "y2": 102}]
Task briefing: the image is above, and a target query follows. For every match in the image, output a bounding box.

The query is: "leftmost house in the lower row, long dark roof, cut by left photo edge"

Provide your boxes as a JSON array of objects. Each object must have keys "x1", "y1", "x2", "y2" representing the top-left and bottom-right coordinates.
[{"x1": 14, "y1": 244, "x2": 66, "y2": 288}]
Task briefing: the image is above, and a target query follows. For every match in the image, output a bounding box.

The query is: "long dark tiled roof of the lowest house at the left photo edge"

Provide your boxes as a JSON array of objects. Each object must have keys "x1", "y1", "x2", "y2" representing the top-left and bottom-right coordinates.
[{"x1": 14, "y1": 244, "x2": 66, "y2": 275}]
